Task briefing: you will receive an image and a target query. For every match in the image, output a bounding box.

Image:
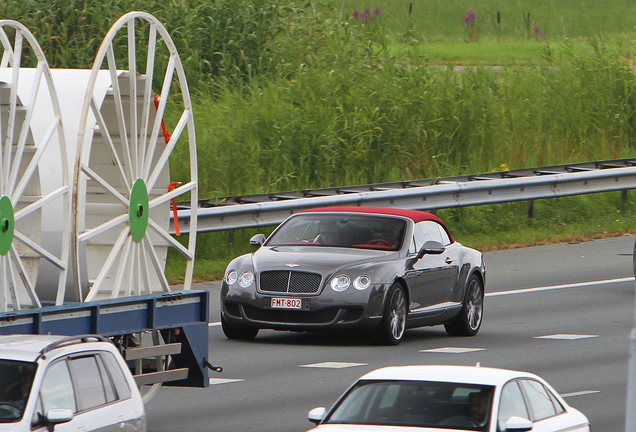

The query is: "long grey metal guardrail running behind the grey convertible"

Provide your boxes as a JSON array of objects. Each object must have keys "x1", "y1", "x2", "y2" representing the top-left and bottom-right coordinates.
[{"x1": 170, "y1": 159, "x2": 636, "y2": 233}]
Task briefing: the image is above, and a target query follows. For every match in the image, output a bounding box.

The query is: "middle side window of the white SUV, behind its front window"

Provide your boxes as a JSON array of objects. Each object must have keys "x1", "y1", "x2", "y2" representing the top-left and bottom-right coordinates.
[{"x1": 69, "y1": 355, "x2": 106, "y2": 411}]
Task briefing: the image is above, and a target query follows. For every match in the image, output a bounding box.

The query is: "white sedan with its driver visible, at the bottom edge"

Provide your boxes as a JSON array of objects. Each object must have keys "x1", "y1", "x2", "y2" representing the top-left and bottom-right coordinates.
[{"x1": 309, "y1": 365, "x2": 591, "y2": 432}]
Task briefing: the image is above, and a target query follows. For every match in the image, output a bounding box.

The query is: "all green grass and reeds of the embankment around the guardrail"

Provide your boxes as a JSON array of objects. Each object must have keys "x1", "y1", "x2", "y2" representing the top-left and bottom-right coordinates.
[{"x1": 3, "y1": 0, "x2": 636, "y2": 282}]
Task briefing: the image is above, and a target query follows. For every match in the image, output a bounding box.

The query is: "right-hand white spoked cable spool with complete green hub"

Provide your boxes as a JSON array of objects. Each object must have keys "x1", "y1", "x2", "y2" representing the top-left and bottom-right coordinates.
[{"x1": 67, "y1": 12, "x2": 198, "y2": 301}]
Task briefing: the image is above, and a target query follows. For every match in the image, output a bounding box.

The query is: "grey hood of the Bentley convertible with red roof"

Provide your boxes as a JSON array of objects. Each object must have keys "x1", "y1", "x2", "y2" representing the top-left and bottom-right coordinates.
[{"x1": 253, "y1": 246, "x2": 398, "y2": 273}]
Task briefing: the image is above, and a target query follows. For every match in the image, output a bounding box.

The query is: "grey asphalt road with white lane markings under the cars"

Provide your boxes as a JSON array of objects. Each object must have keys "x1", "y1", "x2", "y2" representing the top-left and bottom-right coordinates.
[{"x1": 146, "y1": 236, "x2": 636, "y2": 432}]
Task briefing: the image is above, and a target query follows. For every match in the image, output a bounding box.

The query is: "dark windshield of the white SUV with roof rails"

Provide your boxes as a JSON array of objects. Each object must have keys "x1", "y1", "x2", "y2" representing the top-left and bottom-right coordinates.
[{"x1": 0, "y1": 359, "x2": 36, "y2": 423}]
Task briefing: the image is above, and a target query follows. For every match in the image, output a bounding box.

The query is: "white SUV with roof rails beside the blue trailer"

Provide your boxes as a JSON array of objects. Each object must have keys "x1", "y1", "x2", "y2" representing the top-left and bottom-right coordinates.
[{"x1": 0, "y1": 335, "x2": 146, "y2": 432}]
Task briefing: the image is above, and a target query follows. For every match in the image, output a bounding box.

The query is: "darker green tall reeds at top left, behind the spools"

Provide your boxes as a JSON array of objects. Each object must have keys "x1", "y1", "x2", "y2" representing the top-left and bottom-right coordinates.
[{"x1": 0, "y1": 0, "x2": 304, "y2": 93}]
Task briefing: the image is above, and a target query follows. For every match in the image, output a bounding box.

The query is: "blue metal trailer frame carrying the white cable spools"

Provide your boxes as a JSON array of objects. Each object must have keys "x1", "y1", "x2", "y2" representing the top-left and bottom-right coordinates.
[{"x1": 0, "y1": 291, "x2": 211, "y2": 387}]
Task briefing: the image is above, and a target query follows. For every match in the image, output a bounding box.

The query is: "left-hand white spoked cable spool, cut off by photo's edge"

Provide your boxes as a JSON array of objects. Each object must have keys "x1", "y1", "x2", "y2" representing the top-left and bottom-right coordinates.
[{"x1": 0, "y1": 20, "x2": 71, "y2": 312}]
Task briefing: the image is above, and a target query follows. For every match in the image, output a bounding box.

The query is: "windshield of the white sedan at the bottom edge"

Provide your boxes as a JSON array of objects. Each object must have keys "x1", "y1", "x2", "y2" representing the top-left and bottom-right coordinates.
[{"x1": 325, "y1": 381, "x2": 494, "y2": 431}]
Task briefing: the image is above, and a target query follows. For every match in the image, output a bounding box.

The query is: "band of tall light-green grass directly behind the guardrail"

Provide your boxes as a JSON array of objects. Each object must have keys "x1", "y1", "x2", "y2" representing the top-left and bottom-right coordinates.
[{"x1": 191, "y1": 27, "x2": 636, "y2": 196}]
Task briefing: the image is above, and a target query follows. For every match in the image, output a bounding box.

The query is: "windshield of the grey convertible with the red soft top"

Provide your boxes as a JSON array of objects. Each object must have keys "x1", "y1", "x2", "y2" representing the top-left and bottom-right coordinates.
[{"x1": 267, "y1": 213, "x2": 406, "y2": 250}]
